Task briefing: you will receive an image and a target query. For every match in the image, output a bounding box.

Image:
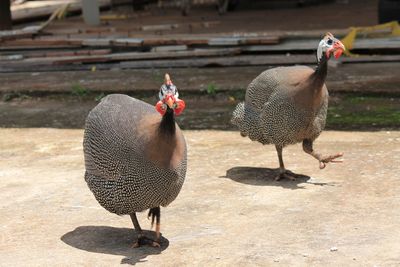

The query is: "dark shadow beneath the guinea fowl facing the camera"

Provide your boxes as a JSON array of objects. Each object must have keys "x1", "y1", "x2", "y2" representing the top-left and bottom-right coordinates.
[{"x1": 61, "y1": 226, "x2": 169, "y2": 265}]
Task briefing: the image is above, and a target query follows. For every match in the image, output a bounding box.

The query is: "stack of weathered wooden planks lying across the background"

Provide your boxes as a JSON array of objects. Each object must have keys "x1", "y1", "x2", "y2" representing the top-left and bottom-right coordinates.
[{"x1": 0, "y1": 32, "x2": 400, "y2": 72}]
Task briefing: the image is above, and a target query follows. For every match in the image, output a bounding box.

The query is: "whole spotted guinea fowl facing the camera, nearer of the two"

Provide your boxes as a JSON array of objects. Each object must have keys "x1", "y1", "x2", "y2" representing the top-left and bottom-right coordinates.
[{"x1": 83, "y1": 74, "x2": 186, "y2": 247}]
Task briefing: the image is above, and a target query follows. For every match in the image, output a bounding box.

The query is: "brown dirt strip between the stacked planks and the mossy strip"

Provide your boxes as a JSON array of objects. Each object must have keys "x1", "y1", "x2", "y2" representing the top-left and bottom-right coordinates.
[{"x1": 0, "y1": 62, "x2": 400, "y2": 94}]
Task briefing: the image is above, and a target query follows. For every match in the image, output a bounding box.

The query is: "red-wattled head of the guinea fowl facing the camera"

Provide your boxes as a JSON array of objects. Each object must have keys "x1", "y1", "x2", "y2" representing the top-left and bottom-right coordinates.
[{"x1": 156, "y1": 73, "x2": 185, "y2": 115}]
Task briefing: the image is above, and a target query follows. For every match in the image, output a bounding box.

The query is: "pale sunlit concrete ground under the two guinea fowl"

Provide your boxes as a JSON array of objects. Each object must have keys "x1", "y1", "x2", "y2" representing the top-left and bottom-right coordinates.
[{"x1": 0, "y1": 128, "x2": 400, "y2": 266}]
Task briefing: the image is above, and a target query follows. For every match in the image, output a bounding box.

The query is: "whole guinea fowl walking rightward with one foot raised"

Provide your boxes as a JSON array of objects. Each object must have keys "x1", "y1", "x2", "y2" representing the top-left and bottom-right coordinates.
[{"x1": 231, "y1": 33, "x2": 345, "y2": 180}]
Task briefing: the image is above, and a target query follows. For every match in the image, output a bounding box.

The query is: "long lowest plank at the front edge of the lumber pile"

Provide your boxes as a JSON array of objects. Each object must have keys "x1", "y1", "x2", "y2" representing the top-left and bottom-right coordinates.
[{"x1": 0, "y1": 54, "x2": 400, "y2": 73}]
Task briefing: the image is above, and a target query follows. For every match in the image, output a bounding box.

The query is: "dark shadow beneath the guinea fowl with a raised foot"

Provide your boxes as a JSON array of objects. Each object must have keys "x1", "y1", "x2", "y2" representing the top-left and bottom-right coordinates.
[{"x1": 221, "y1": 166, "x2": 318, "y2": 189}]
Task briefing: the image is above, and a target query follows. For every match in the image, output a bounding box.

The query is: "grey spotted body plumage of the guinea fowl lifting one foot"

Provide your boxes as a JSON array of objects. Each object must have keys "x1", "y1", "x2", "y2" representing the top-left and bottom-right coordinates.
[{"x1": 232, "y1": 66, "x2": 328, "y2": 147}]
